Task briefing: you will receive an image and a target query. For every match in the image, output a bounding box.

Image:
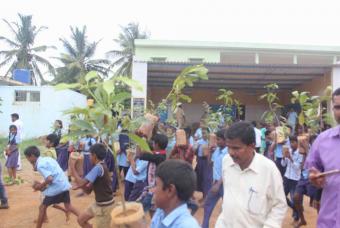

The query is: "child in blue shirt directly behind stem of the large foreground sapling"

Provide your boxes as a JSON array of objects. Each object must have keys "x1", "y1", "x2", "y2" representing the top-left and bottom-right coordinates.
[{"x1": 117, "y1": 130, "x2": 130, "y2": 178}]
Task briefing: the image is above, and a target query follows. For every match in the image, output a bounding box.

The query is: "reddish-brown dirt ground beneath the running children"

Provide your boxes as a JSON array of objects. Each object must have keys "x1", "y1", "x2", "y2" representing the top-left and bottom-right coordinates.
[{"x1": 0, "y1": 161, "x2": 317, "y2": 228}]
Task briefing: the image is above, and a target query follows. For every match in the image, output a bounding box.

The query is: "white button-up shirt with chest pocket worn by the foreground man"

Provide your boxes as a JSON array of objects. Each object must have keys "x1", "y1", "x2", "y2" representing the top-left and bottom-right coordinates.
[{"x1": 215, "y1": 153, "x2": 287, "y2": 228}]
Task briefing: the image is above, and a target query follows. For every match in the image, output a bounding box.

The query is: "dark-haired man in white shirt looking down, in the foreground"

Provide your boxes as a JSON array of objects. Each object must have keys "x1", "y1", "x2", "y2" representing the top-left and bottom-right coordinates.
[{"x1": 215, "y1": 122, "x2": 287, "y2": 228}]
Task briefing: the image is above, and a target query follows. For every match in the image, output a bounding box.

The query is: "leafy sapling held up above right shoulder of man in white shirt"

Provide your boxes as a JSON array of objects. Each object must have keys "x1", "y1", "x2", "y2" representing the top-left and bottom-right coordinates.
[{"x1": 259, "y1": 83, "x2": 282, "y2": 125}]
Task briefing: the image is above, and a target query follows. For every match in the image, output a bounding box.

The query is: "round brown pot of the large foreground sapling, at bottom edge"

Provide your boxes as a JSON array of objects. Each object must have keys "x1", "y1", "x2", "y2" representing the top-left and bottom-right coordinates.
[{"x1": 111, "y1": 202, "x2": 146, "y2": 228}]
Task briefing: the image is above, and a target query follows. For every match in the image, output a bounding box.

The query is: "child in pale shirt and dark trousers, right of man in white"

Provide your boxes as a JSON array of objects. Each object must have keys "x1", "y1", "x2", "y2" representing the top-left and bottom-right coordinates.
[{"x1": 281, "y1": 136, "x2": 304, "y2": 221}]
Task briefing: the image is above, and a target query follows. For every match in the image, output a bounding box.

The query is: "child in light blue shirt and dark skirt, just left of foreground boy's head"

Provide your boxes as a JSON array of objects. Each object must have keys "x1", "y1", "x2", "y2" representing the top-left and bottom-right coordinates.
[{"x1": 128, "y1": 147, "x2": 149, "y2": 201}]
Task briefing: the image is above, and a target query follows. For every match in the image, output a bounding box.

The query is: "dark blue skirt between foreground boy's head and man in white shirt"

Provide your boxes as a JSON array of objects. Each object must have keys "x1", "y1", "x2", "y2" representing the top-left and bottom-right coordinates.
[{"x1": 195, "y1": 157, "x2": 213, "y2": 197}]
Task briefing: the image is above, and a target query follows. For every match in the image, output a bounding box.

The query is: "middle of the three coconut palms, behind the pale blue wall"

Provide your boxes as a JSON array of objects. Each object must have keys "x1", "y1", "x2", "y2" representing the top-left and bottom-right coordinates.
[{"x1": 55, "y1": 26, "x2": 110, "y2": 83}]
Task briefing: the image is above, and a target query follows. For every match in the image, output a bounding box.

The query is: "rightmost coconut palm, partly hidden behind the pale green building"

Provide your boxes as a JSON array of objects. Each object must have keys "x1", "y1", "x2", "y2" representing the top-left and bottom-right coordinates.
[{"x1": 107, "y1": 23, "x2": 150, "y2": 76}]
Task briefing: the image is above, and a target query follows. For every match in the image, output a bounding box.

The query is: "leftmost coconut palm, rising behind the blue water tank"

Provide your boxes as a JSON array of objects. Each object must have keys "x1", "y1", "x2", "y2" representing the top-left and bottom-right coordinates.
[{"x1": 0, "y1": 14, "x2": 55, "y2": 83}]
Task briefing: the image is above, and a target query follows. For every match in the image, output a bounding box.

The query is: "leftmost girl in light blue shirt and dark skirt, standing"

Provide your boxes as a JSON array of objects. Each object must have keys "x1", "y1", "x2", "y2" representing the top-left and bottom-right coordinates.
[{"x1": 5, "y1": 125, "x2": 20, "y2": 185}]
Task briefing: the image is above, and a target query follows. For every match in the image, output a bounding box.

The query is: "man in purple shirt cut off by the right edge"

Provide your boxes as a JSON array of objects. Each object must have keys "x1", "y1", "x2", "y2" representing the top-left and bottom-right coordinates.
[{"x1": 306, "y1": 88, "x2": 340, "y2": 228}]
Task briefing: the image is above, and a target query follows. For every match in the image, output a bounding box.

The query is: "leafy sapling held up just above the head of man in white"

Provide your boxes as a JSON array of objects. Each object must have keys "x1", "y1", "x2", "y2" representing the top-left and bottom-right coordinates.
[{"x1": 217, "y1": 89, "x2": 242, "y2": 125}]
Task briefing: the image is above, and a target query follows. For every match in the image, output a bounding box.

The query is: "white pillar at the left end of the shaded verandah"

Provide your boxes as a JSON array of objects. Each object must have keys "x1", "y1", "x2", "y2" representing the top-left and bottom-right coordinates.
[{"x1": 131, "y1": 60, "x2": 148, "y2": 118}]
